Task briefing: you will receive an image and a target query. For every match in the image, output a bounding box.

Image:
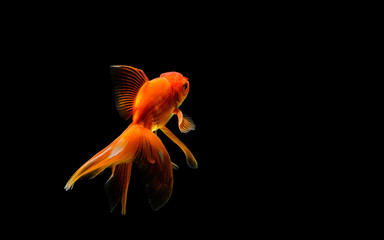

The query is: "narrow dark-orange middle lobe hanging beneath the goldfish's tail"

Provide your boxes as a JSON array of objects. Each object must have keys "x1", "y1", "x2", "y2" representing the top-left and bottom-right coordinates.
[{"x1": 105, "y1": 162, "x2": 132, "y2": 215}]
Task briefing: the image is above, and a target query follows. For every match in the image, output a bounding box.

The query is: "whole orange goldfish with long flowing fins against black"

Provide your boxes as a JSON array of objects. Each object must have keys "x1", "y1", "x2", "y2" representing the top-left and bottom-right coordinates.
[{"x1": 65, "y1": 65, "x2": 197, "y2": 214}]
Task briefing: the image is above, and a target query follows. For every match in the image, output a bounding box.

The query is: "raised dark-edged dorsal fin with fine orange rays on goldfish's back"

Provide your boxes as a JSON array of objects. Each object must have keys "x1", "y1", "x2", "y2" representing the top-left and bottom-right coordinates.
[{"x1": 111, "y1": 65, "x2": 148, "y2": 120}]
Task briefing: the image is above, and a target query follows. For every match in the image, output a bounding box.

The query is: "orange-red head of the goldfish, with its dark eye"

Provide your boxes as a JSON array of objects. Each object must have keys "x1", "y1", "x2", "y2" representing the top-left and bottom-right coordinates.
[{"x1": 160, "y1": 72, "x2": 189, "y2": 106}]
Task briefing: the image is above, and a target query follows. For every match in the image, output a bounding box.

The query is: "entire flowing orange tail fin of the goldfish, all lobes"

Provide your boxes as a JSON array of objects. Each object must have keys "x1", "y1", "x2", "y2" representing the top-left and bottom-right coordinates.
[{"x1": 65, "y1": 124, "x2": 173, "y2": 214}]
